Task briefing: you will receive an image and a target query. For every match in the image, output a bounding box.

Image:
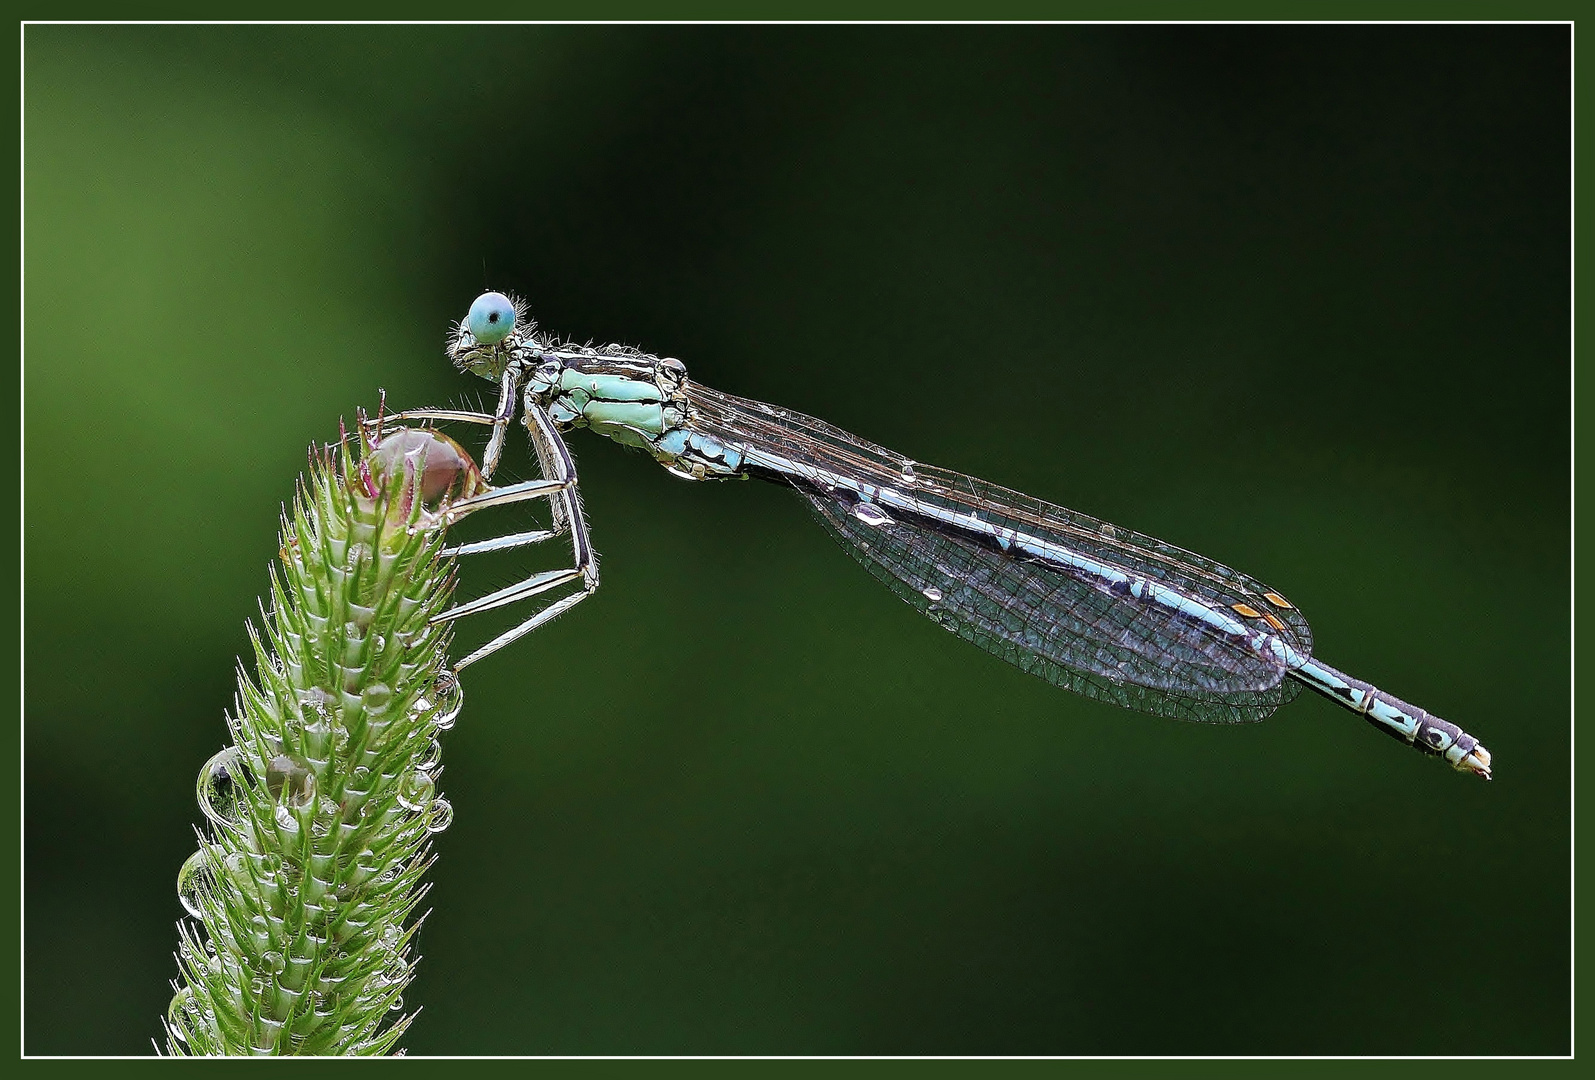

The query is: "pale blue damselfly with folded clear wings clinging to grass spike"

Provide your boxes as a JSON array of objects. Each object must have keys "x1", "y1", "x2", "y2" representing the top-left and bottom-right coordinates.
[{"x1": 370, "y1": 292, "x2": 1490, "y2": 778}]
